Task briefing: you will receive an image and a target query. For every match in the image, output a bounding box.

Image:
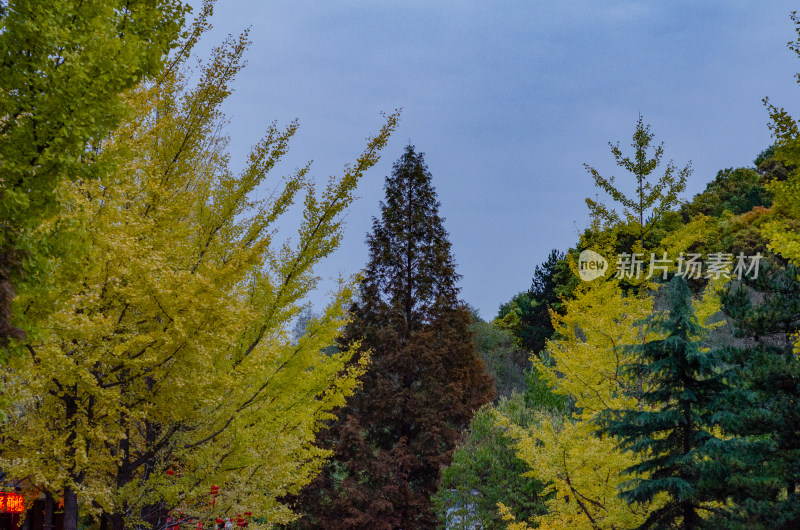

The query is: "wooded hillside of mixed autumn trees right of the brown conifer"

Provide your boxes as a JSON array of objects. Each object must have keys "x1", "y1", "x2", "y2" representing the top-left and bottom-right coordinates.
[{"x1": 435, "y1": 134, "x2": 800, "y2": 528}]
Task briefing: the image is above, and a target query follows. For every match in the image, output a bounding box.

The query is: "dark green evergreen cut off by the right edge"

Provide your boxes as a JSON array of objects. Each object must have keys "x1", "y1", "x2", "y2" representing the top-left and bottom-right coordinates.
[{"x1": 715, "y1": 262, "x2": 800, "y2": 529}]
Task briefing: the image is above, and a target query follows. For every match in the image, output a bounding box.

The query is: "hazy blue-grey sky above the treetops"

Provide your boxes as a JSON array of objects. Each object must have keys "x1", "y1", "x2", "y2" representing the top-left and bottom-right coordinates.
[{"x1": 193, "y1": 0, "x2": 800, "y2": 319}]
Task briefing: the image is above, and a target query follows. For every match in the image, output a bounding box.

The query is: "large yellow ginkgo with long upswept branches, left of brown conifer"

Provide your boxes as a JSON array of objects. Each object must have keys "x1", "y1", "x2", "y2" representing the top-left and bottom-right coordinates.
[{"x1": 0, "y1": 4, "x2": 398, "y2": 529}]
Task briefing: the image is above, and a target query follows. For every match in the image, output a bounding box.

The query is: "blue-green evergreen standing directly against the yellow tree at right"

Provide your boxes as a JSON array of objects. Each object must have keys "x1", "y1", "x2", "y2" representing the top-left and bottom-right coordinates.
[{"x1": 598, "y1": 276, "x2": 722, "y2": 529}]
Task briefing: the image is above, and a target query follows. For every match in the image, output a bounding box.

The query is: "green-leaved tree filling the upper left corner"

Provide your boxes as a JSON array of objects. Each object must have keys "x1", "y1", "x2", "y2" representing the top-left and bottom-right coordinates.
[{"x1": 0, "y1": 0, "x2": 188, "y2": 346}]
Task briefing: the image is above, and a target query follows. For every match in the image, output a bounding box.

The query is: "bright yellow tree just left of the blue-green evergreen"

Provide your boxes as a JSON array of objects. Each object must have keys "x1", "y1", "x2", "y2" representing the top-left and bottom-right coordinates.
[{"x1": 501, "y1": 280, "x2": 653, "y2": 529}]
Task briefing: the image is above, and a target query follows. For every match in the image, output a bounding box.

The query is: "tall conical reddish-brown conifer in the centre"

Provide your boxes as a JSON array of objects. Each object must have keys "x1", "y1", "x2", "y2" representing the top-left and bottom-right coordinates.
[{"x1": 298, "y1": 145, "x2": 494, "y2": 530}]
